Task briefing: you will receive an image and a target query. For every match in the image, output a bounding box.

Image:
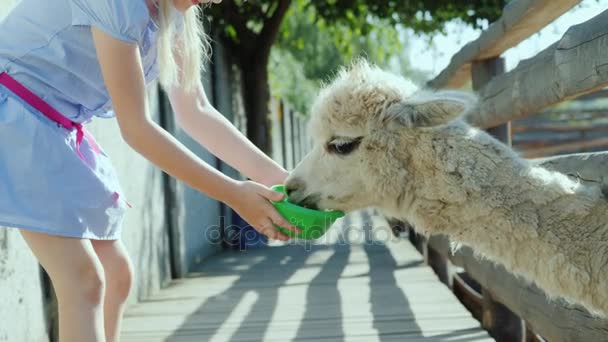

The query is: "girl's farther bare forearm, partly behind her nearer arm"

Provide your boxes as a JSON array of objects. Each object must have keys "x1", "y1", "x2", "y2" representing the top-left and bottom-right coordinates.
[{"x1": 168, "y1": 44, "x2": 288, "y2": 186}]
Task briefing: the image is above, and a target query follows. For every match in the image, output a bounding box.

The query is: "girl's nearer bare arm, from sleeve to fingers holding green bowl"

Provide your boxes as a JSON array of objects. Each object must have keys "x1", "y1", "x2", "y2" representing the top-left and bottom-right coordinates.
[{"x1": 91, "y1": 27, "x2": 297, "y2": 240}]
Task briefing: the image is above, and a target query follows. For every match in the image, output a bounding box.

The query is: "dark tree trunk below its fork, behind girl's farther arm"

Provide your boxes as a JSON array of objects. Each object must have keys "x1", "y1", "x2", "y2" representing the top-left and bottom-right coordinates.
[{"x1": 239, "y1": 52, "x2": 272, "y2": 155}]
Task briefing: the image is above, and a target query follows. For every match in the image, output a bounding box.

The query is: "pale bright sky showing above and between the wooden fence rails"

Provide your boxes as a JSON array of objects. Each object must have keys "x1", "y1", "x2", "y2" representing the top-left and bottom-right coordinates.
[{"x1": 408, "y1": 0, "x2": 608, "y2": 77}]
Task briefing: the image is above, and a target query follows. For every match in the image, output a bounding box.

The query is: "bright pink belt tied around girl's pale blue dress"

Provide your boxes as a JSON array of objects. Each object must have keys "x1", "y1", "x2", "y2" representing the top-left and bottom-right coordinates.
[{"x1": 0, "y1": 72, "x2": 131, "y2": 207}]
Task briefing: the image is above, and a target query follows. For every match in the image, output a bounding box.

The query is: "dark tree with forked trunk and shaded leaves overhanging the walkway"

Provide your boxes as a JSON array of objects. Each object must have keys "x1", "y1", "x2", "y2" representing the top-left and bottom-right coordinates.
[{"x1": 211, "y1": 0, "x2": 505, "y2": 152}]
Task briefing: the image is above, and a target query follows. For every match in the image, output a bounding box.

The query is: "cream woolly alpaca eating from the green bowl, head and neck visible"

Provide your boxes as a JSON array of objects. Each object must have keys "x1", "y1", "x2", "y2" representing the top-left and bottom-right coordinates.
[{"x1": 286, "y1": 61, "x2": 608, "y2": 317}]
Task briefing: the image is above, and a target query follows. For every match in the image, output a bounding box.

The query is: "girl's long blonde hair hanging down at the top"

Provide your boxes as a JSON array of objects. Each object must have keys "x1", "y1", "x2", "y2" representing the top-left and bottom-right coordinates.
[{"x1": 158, "y1": 0, "x2": 211, "y2": 91}]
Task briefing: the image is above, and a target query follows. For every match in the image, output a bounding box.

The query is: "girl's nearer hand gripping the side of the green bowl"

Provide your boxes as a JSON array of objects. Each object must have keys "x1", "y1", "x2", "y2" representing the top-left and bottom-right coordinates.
[{"x1": 227, "y1": 181, "x2": 301, "y2": 241}]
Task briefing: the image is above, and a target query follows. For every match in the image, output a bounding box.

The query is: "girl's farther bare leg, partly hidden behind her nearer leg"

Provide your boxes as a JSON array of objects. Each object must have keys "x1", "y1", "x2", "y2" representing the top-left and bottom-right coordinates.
[{"x1": 91, "y1": 240, "x2": 133, "y2": 342}]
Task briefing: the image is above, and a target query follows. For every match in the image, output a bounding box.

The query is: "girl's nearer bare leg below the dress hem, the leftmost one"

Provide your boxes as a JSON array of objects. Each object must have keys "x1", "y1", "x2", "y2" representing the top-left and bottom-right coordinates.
[{"x1": 20, "y1": 230, "x2": 105, "y2": 342}]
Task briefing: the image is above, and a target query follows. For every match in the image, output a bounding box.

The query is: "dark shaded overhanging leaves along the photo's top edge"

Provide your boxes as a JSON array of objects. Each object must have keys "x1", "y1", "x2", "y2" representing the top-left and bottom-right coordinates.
[{"x1": 211, "y1": 0, "x2": 508, "y2": 41}]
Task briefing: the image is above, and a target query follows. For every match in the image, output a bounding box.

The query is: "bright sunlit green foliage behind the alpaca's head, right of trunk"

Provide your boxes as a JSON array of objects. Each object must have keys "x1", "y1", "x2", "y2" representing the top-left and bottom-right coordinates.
[{"x1": 269, "y1": 1, "x2": 427, "y2": 113}]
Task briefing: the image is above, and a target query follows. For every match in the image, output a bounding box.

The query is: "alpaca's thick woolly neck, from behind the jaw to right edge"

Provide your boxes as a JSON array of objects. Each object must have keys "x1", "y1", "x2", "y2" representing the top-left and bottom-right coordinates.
[{"x1": 385, "y1": 127, "x2": 608, "y2": 313}]
